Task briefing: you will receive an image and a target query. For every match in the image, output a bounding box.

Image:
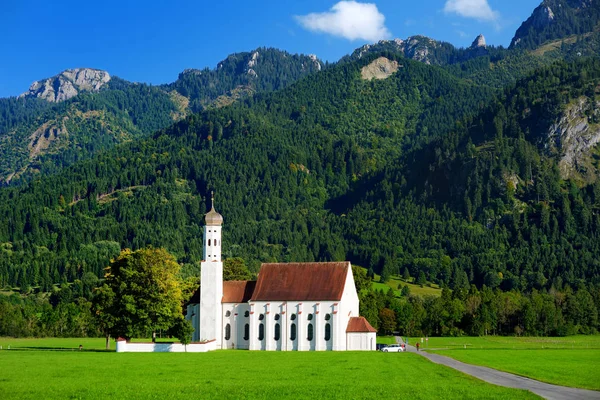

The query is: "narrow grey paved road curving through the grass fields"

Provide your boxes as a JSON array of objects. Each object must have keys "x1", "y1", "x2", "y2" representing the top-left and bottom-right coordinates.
[{"x1": 396, "y1": 337, "x2": 600, "y2": 400}]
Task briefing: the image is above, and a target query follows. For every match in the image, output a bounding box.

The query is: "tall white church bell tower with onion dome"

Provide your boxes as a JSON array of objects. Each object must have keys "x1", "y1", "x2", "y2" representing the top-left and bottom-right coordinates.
[{"x1": 200, "y1": 192, "x2": 223, "y2": 348}]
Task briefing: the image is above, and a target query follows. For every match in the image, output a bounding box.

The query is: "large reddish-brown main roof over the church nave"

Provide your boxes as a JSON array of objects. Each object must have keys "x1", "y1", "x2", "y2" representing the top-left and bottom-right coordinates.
[{"x1": 251, "y1": 262, "x2": 350, "y2": 301}]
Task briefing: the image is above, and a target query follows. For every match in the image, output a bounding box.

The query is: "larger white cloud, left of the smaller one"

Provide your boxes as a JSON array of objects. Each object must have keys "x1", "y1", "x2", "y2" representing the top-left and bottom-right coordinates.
[{"x1": 295, "y1": 1, "x2": 392, "y2": 42}]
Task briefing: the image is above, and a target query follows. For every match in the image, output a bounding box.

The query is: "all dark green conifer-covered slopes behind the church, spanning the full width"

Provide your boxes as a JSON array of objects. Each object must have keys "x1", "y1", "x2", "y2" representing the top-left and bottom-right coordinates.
[{"x1": 0, "y1": 55, "x2": 600, "y2": 290}]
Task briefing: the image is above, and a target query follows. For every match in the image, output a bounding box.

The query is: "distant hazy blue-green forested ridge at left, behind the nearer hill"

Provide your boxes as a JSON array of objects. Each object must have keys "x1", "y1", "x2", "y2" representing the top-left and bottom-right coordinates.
[{"x1": 0, "y1": 48, "x2": 325, "y2": 185}]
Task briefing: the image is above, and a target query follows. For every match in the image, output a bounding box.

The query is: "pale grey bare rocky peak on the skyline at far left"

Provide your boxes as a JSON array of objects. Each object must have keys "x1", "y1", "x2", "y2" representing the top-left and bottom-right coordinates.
[{"x1": 19, "y1": 68, "x2": 110, "y2": 103}]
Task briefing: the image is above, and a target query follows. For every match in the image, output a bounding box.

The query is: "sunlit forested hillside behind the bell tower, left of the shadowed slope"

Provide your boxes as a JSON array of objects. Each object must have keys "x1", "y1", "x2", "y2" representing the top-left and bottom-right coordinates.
[{"x1": 0, "y1": 56, "x2": 492, "y2": 287}]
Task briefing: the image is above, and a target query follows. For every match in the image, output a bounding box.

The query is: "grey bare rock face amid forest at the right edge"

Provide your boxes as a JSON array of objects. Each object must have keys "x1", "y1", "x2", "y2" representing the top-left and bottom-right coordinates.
[{"x1": 548, "y1": 96, "x2": 600, "y2": 182}]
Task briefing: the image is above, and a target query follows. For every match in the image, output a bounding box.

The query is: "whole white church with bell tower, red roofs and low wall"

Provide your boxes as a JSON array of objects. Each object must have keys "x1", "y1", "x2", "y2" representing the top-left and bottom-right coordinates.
[{"x1": 117, "y1": 195, "x2": 376, "y2": 352}]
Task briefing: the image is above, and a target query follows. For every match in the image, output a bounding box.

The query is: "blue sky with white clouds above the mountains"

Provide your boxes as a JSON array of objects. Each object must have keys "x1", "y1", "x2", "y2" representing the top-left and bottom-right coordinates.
[{"x1": 0, "y1": 0, "x2": 541, "y2": 97}]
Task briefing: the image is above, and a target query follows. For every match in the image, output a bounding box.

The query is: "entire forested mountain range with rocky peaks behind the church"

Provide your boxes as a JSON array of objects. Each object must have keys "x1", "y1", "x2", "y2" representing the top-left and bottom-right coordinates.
[{"x1": 0, "y1": 0, "x2": 600, "y2": 298}]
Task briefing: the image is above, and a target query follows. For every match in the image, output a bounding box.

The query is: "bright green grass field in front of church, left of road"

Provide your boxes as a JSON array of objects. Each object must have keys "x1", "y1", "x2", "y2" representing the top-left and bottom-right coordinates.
[{"x1": 0, "y1": 339, "x2": 537, "y2": 400}]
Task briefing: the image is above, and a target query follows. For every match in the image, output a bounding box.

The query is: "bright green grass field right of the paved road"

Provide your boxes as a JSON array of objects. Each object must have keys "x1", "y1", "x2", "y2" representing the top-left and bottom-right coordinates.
[{"x1": 409, "y1": 336, "x2": 600, "y2": 390}]
